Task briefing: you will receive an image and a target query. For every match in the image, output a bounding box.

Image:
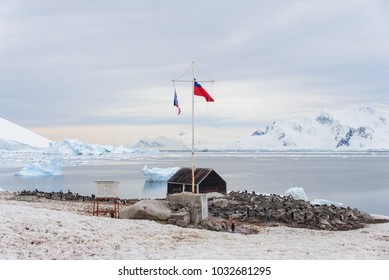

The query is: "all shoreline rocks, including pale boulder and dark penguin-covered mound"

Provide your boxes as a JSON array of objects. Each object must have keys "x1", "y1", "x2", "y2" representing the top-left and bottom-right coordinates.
[{"x1": 13, "y1": 189, "x2": 389, "y2": 231}]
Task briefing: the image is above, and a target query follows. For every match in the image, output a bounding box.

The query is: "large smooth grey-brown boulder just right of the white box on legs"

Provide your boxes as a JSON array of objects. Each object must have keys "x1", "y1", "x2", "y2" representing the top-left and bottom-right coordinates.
[{"x1": 120, "y1": 200, "x2": 171, "y2": 221}]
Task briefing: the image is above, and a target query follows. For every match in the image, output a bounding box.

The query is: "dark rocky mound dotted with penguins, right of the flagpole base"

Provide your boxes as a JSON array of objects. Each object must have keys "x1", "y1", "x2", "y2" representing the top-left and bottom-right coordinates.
[{"x1": 202, "y1": 192, "x2": 389, "y2": 230}]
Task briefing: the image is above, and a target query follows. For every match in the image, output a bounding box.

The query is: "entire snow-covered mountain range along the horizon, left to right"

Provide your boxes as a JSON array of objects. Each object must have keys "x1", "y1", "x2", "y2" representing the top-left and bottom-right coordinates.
[{"x1": 0, "y1": 106, "x2": 389, "y2": 155}]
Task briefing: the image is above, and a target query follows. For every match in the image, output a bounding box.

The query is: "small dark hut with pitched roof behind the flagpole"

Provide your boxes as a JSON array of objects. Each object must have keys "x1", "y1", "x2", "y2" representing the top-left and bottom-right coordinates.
[{"x1": 167, "y1": 167, "x2": 227, "y2": 194}]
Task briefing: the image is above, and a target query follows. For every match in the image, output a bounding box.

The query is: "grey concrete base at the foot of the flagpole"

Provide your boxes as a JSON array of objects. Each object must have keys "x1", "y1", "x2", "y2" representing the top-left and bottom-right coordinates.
[{"x1": 167, "y1": 192, "x2": 208, "y2": 224}]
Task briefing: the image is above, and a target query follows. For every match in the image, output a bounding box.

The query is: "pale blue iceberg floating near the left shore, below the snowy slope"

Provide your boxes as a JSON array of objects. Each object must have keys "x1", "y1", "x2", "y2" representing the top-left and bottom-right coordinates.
[{"x1": 15, "y1": 159, "x2": 63, "y2": 176}]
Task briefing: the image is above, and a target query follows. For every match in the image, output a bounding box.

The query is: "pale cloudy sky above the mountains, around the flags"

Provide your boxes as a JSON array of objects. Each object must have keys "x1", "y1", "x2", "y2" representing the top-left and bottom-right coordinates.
[{"x1": 0, "y1": 0, "x2": 389, "y2": 145}]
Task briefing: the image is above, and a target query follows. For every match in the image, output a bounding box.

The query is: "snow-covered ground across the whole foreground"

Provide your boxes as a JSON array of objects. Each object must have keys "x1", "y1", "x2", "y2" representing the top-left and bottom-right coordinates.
[{"x1": 0, "y1": 192, "x2": 389, "y2": 260}]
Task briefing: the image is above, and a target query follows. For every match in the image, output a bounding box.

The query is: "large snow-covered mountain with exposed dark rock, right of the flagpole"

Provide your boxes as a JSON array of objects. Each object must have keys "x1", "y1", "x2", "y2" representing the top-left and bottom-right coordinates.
[{"x1": 229, "y1": 106, "x2": 389, "y2": 150}]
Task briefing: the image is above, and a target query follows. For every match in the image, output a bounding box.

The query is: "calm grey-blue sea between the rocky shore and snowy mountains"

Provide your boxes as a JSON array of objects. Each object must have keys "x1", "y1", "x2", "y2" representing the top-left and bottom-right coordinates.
[{"x1": 0, "y1": 152, "x2": 389, "y2": 216}]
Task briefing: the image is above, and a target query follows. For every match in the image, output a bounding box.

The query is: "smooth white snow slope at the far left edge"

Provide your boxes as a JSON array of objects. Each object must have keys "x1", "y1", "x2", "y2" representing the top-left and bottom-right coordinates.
[{"x1": 0, "y1": 118, "x2": 51, "y2": 151}]
